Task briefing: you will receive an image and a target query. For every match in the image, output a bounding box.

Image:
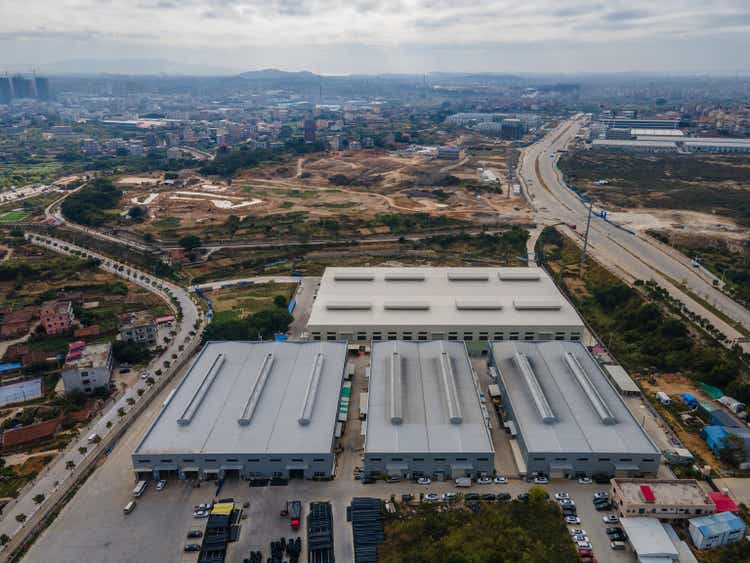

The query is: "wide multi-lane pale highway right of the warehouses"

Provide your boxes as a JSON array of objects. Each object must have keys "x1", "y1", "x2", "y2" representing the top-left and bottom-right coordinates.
[{"x1": 519, "y1": 119, "x2": 750, "y2": 351}]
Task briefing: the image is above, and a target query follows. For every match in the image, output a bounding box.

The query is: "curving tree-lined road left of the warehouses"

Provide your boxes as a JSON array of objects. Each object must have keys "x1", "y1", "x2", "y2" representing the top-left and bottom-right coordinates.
[{"x1": 0, "y1": 233, "x2": 201, "y2": 552}]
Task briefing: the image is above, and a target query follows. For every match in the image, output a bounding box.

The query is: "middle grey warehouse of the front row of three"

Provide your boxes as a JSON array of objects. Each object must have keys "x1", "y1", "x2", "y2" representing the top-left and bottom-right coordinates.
[{"x1": 364, "y1": 341, "x2": 494, "y2": 479}]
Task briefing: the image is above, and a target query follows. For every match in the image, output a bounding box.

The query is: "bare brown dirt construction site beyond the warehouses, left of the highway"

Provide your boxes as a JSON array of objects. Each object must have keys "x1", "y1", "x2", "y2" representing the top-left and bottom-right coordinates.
[{"x1": 118, "y1": 150, "x2": 530, "y2": 236}]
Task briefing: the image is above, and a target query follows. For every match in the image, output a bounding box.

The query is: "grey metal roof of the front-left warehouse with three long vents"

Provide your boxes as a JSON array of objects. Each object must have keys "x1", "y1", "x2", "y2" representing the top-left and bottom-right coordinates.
[{"x1": 135, "y1": 341, "x2": 346, "y2": 454}]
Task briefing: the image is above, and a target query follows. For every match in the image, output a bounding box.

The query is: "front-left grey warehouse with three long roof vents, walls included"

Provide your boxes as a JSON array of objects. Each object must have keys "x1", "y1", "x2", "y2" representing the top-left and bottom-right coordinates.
[{"x1": 132, "y1": 342, "x2": 346, "y2": 479}]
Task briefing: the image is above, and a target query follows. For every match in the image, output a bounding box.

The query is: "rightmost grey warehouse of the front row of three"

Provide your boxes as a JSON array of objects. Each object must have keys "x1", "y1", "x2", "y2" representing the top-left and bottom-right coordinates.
[{"x1": 490, "y1": 342, "x2": 661, "y2": 478}]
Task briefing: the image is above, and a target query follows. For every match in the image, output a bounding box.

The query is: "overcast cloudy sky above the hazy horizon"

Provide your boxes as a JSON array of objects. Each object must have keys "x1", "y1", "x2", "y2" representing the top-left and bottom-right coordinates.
[{"x1": 0, "y1": 0, "x2": 750, "y2": 74}]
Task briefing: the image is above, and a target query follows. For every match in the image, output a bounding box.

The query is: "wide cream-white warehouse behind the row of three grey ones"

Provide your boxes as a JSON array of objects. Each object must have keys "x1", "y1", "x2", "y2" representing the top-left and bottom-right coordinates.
[{"x1": 307, "y1": 268, "x2": 583, "y2": 349}]
